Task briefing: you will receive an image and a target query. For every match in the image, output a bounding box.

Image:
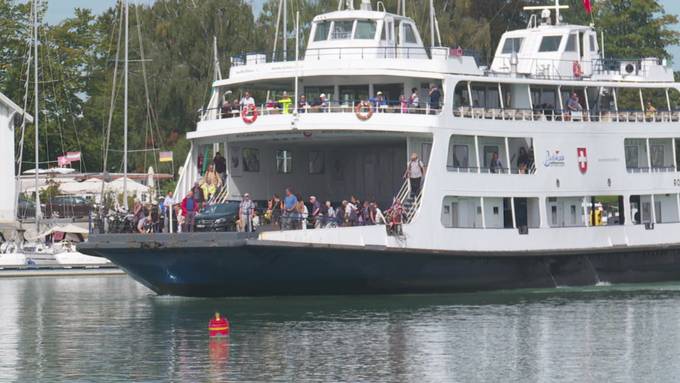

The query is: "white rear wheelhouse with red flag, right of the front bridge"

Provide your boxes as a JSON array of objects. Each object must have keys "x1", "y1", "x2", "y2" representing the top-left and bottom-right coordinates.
[{"x1": 490, "y1": 0, "x2": 673, "y2": 82}]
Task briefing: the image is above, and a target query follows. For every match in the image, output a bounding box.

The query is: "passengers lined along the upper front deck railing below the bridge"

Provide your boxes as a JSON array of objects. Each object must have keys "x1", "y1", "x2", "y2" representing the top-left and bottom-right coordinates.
[{"x1": 220, "y1": 84, "x2": 442, "y2": 118}]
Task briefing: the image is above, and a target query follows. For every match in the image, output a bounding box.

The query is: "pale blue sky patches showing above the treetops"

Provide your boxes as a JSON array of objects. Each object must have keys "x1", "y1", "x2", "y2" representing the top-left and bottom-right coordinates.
[{"x1": 42, "y1": 0, "x2": 680, "y2": 69}]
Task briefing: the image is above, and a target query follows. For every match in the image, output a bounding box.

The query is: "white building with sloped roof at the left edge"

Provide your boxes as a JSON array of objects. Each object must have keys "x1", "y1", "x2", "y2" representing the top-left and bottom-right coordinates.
[{"x1": 0, "y1": 93, "x2": 33, "y2": 224}]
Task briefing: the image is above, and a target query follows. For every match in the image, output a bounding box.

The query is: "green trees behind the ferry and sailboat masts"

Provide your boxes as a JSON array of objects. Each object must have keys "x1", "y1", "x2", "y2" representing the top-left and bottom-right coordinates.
[{"x1": 0, "y1": 0, "x2": 680, "y2": 192}]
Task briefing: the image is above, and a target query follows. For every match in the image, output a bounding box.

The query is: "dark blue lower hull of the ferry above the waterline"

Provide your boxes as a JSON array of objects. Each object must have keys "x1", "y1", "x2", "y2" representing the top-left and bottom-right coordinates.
[{"x1": 79, "y1": 234, "x2": 680, "y2": 297}]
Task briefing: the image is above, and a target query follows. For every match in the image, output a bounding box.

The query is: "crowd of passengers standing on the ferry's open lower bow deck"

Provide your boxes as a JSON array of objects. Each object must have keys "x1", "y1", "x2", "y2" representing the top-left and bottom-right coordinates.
[{"x1": 128, "y1": 152, "x2": 426, "y2": 233}]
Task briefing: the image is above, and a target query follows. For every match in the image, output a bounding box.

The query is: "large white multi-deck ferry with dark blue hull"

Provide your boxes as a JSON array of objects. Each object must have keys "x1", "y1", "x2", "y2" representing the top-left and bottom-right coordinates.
[{"x1": 80, "y1": 0, "x2": 680, "y2": 296}]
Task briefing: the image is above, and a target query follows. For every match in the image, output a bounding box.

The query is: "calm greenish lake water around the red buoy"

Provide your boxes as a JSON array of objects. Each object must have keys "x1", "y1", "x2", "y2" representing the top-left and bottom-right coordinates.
[{"x1": 0, "y1": 276, "x2": 680, "y2": 382}]
